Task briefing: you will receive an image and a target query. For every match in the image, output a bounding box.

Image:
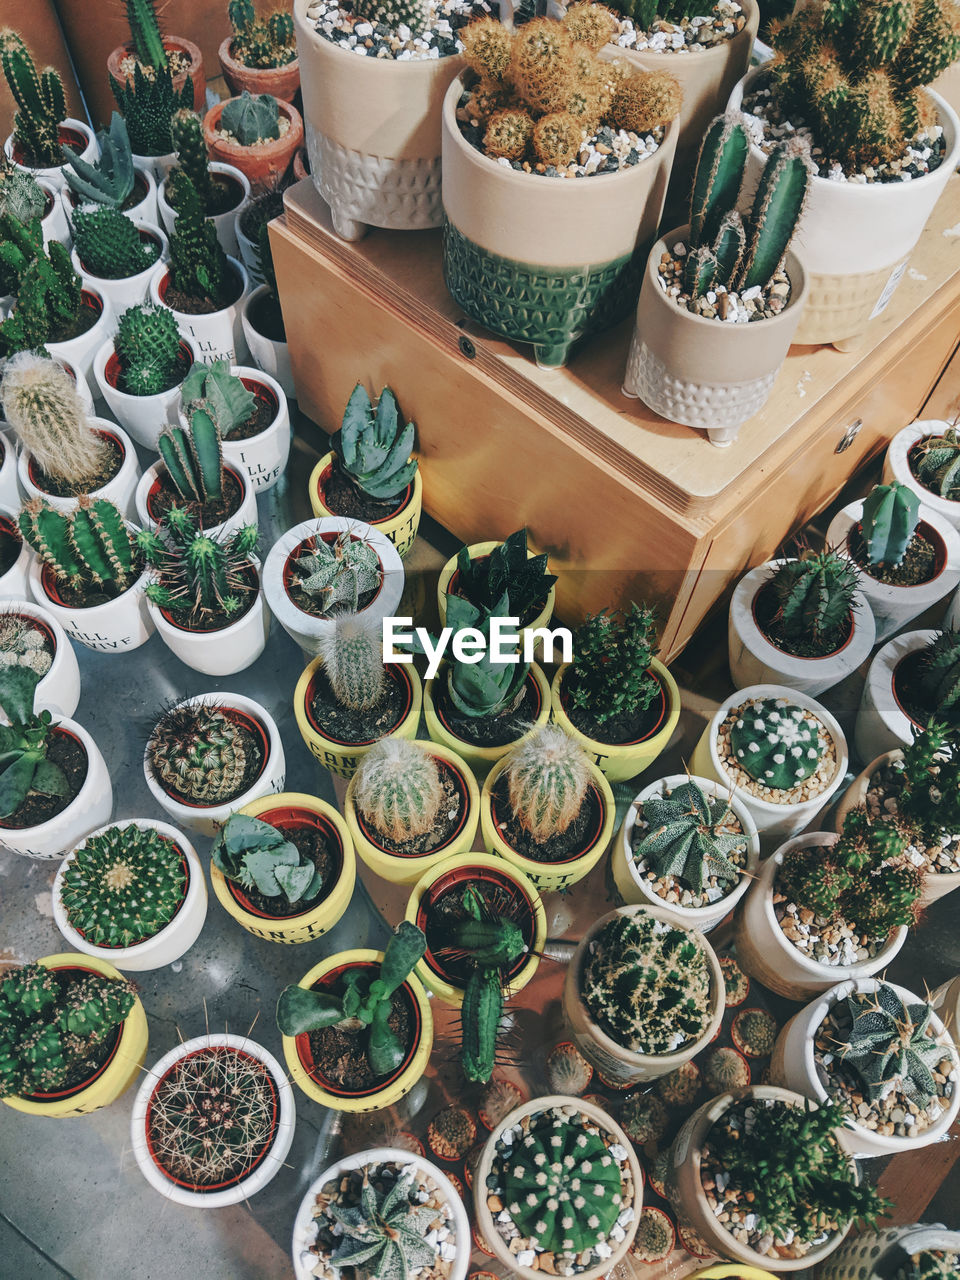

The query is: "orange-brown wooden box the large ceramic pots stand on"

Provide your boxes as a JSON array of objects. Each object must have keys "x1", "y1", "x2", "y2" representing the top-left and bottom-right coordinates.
[{"x1": 271, "y1": 175, "x2": 960, "y2": 658}]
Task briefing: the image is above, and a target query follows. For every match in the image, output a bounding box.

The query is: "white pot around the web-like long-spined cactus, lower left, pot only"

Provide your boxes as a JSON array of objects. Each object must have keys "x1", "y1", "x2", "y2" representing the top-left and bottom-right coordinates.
[{"x1": 131, "y1": 1032, "x2": 297, "y2": 1208}]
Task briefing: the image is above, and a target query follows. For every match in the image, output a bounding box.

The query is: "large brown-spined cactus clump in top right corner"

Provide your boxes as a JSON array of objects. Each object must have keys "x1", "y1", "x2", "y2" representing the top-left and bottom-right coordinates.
[{"x1": 769, "y1": 0, "x2": 960, "y2": 169}]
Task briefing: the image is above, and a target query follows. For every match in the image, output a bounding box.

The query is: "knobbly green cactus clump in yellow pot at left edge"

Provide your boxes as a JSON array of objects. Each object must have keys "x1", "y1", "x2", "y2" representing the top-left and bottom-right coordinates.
[{"x1": 0, "y1": 956, "x2": 136, "y2": 1098}]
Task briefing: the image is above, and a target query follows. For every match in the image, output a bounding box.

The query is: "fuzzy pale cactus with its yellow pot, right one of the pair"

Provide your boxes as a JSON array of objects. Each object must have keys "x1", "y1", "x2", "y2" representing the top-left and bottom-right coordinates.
[{"x1": 480, "y1": 724, "x2": 616, "y2": 890}]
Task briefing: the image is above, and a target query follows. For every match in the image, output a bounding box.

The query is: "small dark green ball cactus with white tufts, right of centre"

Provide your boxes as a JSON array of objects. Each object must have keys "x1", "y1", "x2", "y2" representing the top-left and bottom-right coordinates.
[{"x1": 730, "y1": 698, "x2": 823, "y2": 791}]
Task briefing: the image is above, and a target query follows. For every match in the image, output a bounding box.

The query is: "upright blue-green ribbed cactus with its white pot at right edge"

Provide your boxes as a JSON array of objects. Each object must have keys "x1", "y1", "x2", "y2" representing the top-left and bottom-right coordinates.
[{"x1": 827, "y1": 481, "x2": 960, "y2": 643}]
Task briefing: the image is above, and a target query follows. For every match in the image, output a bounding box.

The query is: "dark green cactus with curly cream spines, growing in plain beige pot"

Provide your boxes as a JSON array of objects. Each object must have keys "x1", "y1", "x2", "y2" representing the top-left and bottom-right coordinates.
[{"x1": 581, "y1": 910, "x2": 721, "y2": 1055}]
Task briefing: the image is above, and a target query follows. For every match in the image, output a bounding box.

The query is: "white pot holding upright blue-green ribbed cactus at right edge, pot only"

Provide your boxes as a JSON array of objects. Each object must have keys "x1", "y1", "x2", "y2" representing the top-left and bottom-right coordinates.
[{"x1": 827, "y1": 502, "x2": 960, "y2": 644}]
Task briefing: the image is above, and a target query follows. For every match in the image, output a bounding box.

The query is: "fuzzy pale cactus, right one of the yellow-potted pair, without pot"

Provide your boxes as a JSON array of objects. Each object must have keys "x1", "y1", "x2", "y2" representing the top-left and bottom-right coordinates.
[{"x1": 503, "y1": 724, "x2": 590, "y2": 842}]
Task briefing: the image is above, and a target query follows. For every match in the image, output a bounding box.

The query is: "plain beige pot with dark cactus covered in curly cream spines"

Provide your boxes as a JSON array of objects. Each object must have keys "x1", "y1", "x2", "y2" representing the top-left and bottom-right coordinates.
[{"x1": 563, "y1": 906, "x2": 724, "y2": 1088}]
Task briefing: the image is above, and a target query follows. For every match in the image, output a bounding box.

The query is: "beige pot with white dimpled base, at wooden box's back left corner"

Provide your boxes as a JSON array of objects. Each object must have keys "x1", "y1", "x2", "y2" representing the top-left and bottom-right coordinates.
[{"x1": 293, "y1": 0, "x2": 463, "y2": 241}]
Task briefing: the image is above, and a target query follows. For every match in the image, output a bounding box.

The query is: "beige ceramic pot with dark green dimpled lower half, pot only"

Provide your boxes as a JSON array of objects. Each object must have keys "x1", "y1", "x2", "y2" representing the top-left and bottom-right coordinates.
[{"x1": 443, "y1": 70, "x2": 678, "y2": 369}]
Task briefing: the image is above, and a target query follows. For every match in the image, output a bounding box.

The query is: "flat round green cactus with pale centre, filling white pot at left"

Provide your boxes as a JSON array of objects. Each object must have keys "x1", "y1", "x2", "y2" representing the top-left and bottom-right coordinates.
[{"x1": 60, "y1": 823, "x2": 187, "y2": 947}]
